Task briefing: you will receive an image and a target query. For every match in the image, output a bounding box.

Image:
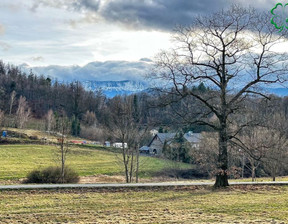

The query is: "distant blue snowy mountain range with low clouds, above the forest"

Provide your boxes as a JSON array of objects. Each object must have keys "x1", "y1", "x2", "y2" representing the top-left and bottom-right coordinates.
[{"x1": 20, "y1": 58, "x2": 288, "y2": 97}]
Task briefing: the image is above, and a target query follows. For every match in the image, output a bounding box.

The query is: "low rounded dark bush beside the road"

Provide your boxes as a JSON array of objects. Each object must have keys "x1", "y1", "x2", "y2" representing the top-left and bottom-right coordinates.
[{"x1": 24, "y1": 166, "x2": 79, "y2": 184}]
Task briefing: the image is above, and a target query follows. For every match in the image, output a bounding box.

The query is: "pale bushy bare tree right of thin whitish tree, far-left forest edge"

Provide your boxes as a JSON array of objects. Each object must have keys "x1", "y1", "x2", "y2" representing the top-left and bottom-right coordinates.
[{"x1": 16, "y1": 96, "x2": 31, "y2": 128}]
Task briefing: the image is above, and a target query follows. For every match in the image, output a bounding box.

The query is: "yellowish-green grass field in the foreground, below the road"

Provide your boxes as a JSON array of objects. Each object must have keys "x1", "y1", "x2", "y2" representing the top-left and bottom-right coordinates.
[{"x1": 0, "y1": 186, "x2": 288, "y2": 223}]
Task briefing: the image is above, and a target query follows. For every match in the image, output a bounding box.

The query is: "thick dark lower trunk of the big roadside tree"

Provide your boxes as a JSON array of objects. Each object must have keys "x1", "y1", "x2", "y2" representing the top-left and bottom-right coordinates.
[{"x1": 214, "y1": 122, "x2": 229, "y2": 188}]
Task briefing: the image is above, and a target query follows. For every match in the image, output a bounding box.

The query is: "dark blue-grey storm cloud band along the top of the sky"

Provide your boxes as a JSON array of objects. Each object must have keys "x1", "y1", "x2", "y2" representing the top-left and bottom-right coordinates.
[{"x1": 33, "y1": 0, "x2": 275, "y2": 30}]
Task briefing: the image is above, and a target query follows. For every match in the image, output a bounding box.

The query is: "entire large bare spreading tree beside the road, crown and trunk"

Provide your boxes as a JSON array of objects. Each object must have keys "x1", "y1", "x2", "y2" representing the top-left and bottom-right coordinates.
[{"x1": 151, "y1": 6, "x2": 287, "y2": 187}]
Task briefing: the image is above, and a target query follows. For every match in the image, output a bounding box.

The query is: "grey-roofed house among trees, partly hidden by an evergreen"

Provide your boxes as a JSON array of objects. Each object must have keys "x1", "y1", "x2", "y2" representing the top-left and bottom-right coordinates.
[{"x1": 147, "y1": 131, "x2": 202, "y2": 155}]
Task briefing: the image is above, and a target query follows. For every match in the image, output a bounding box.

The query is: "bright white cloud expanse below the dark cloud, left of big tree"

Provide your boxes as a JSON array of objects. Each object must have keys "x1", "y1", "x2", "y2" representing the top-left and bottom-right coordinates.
[{"x1": 0, "y1": 0, "x2": 174, "y2": 66}]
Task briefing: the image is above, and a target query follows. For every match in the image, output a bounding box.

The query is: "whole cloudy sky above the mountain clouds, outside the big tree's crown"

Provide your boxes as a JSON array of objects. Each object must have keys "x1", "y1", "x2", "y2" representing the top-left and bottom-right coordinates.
[{"x1": 0, "y1": 0, "x2": 281, "y2": 66}]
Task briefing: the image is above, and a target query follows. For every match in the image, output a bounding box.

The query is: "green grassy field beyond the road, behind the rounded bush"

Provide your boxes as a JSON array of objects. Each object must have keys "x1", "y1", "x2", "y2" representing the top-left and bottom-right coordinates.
[{"x1": 0, "y1": 145, "x2": 190, "y2": 180}]
